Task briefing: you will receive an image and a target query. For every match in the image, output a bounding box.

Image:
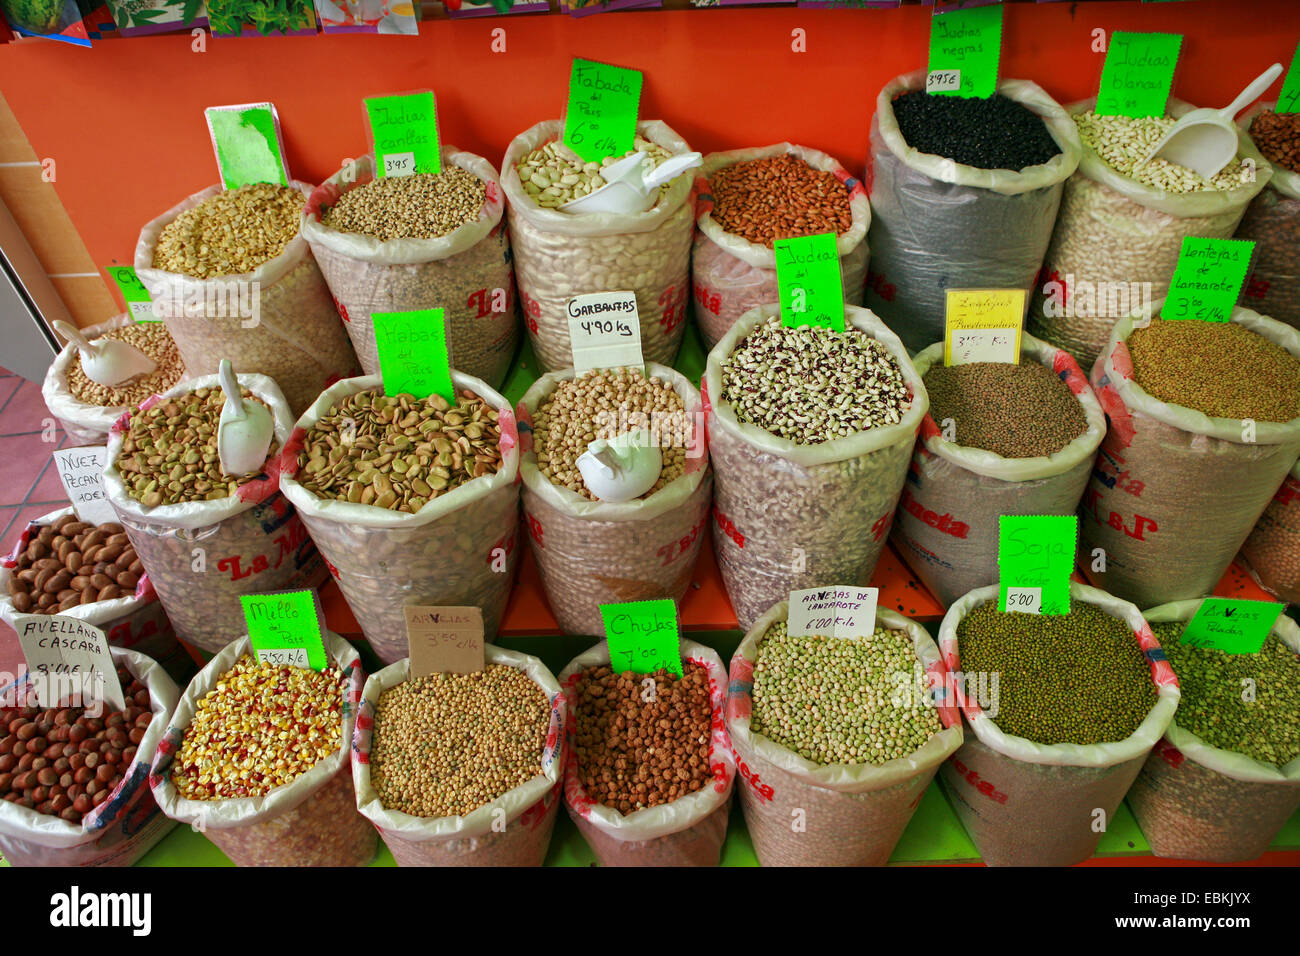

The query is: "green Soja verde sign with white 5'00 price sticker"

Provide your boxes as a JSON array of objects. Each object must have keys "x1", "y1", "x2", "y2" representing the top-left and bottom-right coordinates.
[{"x1": 997, "y1": 515, "x2": 1079, "y2": 614}]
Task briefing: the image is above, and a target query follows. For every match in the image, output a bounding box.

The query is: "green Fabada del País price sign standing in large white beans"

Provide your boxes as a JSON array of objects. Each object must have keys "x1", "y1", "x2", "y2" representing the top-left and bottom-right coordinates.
[{"x1": 564, "y1": 57, "x2": 641, "y2": 163}]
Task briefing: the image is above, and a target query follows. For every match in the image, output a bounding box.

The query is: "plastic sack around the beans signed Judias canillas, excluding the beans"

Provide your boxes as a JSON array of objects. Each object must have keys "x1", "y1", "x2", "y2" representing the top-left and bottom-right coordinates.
[{"x1": 303, "y1": 146, "x2": 519, "y2": 389}]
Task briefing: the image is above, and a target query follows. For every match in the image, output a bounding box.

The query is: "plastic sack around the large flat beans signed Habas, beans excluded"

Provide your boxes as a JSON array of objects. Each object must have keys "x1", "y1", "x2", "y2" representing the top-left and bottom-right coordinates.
[{"x1": 280, "y1": 371, "x2": 519, "y2": 663}]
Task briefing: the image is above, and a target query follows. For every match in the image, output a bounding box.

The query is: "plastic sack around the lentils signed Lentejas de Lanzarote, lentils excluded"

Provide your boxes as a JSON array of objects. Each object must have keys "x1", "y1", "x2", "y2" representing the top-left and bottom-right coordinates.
[{"x1": 1079, "y1": 299, "x2": 1300, "y2": 607}]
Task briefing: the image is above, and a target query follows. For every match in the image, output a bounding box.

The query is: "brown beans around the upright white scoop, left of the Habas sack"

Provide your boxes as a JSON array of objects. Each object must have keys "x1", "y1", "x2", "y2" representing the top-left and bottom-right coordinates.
[{"x1": 117, "y1": 388, "x2": 280, "y2": 507}]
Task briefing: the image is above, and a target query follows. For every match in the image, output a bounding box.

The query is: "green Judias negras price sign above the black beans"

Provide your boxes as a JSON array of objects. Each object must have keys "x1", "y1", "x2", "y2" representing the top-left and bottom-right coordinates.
[{"x1": 926, "y1": 4, "x2": 1002, "y2": 99}]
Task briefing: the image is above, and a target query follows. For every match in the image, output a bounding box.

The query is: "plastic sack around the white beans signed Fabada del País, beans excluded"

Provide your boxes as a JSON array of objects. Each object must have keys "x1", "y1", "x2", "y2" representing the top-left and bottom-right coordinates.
[{"x1": 501, "y1": 120, "x2": 696, "y2": 371}]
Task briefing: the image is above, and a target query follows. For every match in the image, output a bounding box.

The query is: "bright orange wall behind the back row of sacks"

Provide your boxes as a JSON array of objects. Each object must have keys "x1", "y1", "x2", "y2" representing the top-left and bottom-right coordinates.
[{"x1": 0, "y1": 0, "x2": 1300, "y2": 316}]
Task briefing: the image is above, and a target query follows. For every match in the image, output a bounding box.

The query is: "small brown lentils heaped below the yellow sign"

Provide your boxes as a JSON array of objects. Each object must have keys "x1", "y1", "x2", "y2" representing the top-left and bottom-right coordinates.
[{"x1": 924, "y1": 362, "x2": 1088, "y2": 458}]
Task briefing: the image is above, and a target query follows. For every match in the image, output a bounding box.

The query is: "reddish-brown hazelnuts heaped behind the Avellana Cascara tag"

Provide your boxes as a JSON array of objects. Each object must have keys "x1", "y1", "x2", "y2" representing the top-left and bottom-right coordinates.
[{"x1": 0, "y1": 666, "x2": 153, "y2": 823}]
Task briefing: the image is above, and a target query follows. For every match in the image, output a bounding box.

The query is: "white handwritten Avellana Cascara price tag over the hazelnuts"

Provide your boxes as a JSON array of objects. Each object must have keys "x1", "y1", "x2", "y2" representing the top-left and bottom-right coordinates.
[{"x1": 13, "y1": 614, "x2": 126, "y2": 710}]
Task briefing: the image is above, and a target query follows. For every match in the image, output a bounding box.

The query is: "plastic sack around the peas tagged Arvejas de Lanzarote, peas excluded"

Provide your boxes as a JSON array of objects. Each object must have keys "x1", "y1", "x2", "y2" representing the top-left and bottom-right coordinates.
[{"x1": 727, "y1": 601, "x2": 962, "y2": 866}]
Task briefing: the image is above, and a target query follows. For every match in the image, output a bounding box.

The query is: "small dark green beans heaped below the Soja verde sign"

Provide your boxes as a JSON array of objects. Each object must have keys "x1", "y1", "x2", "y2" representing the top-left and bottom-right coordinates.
[{"x1": 957, "y1": 598, "x2": 1157, "y2": 745}]
